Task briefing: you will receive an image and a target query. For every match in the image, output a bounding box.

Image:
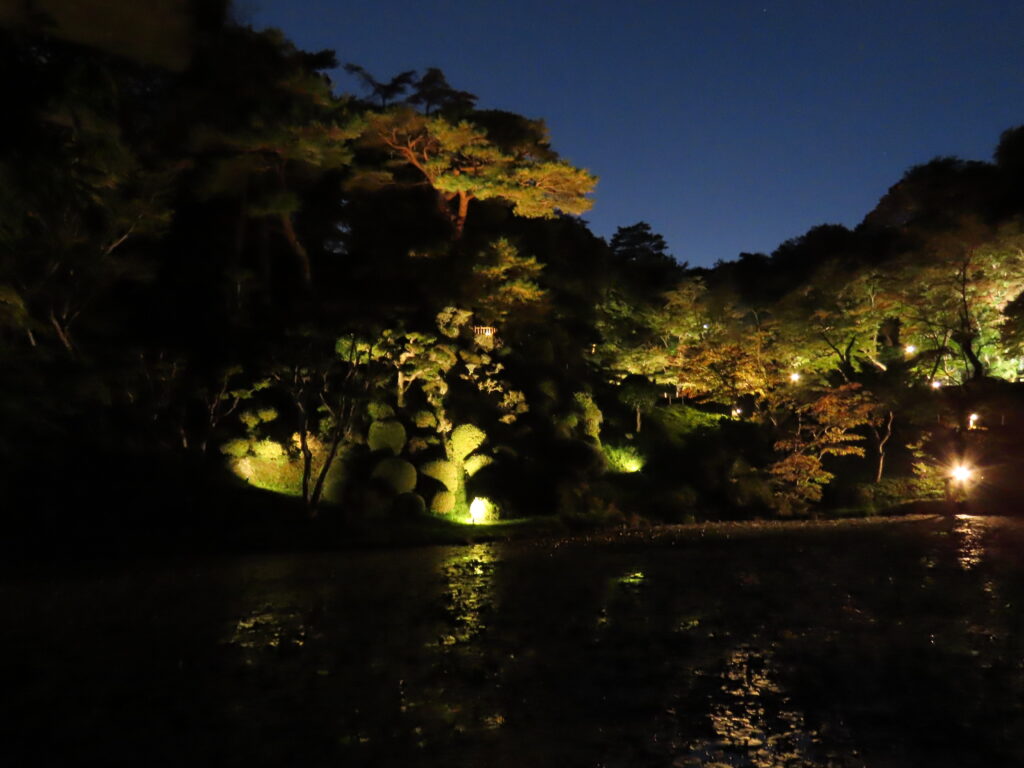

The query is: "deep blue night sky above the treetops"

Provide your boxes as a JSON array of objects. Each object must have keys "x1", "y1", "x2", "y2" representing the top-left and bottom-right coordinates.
[{"x1": 245, "y1": 0, "x2": 1024, "y2": 264}]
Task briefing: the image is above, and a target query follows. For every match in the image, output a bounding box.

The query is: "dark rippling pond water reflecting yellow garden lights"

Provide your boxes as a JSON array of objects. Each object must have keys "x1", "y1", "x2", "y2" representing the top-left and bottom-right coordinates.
[{"x1": 0, "y1": 516, "x2": 1024, "y2": 768}]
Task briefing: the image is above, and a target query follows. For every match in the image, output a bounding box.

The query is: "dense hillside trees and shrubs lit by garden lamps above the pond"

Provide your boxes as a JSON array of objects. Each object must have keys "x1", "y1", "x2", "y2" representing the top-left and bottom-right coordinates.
[{"x1": 0, "y1": 10, "x2": 1024, "y2": 540}]
